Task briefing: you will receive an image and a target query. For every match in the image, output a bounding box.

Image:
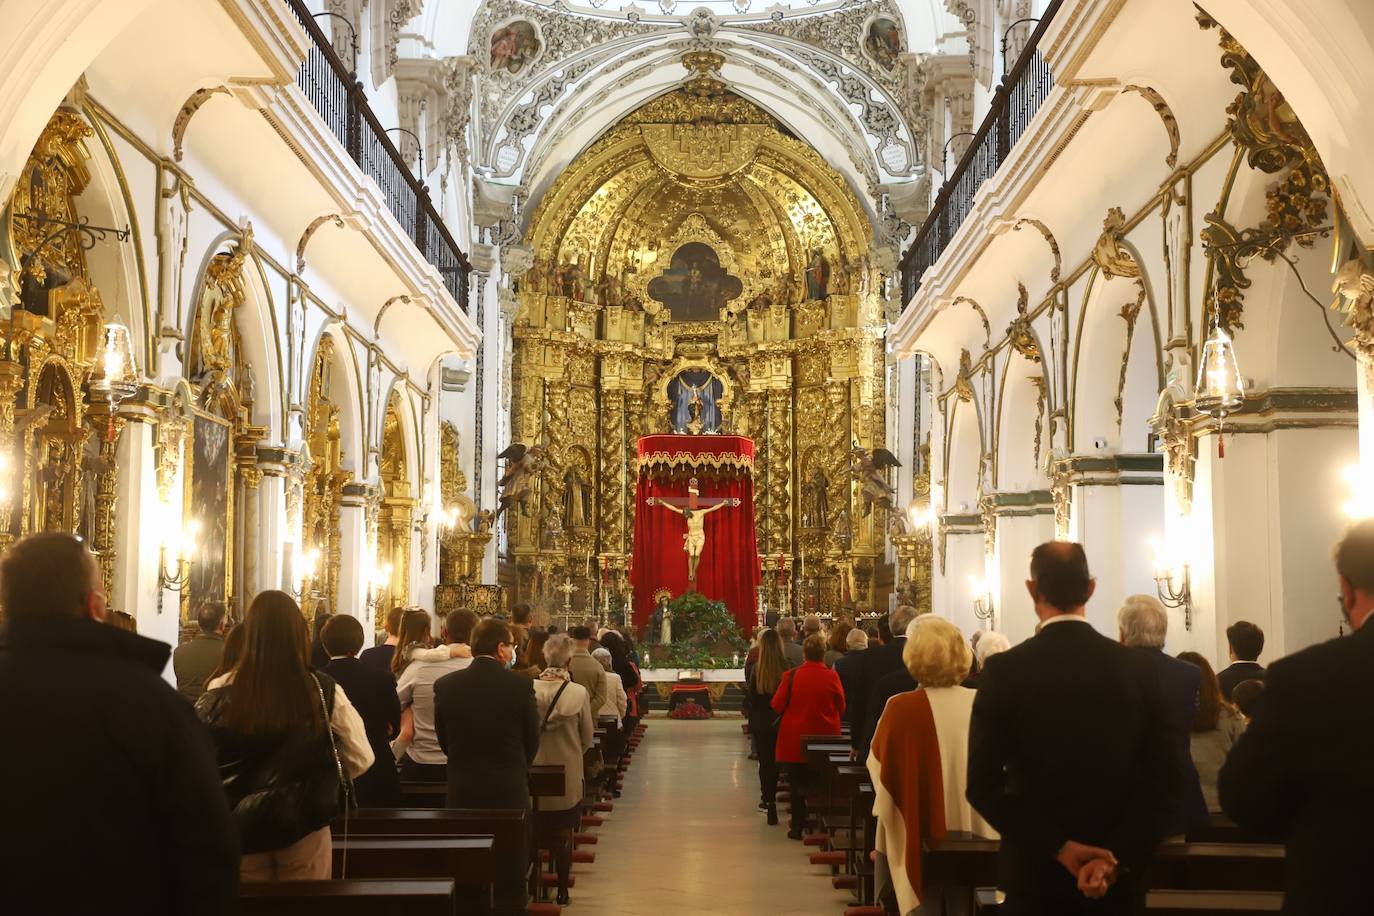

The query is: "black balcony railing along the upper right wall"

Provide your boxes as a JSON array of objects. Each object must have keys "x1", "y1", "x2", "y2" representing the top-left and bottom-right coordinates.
[{"x1": 901, "y1": 0, "x2": 1061, "y2": 308}]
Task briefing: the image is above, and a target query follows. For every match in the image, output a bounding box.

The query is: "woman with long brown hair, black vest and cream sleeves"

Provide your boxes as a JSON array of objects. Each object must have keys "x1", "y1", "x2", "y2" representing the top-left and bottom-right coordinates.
[{"x1": 195, "y1": 591, "x2": 374, "y2": 880}]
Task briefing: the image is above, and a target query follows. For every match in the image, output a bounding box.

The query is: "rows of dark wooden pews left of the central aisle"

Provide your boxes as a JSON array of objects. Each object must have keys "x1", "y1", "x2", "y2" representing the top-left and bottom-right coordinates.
[{"x1": 239, "y1": 718, "x2": 643, "y2": 916}]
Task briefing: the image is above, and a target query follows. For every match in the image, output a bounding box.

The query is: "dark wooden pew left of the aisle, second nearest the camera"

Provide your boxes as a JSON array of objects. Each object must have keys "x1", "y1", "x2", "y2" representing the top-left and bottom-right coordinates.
[{"x1": 334, "y1": 836, "x2": 496, "y2": 913}]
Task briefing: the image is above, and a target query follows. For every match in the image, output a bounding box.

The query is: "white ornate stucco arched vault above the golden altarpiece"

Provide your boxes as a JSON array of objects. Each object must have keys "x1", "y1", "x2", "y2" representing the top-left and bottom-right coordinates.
[{"x1": 469, "y1": 0, "x2": 927, "y2": 236}]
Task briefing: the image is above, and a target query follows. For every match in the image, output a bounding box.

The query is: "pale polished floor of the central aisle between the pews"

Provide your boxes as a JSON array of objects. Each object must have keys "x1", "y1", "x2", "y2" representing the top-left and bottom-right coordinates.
[{"x1": 569, "y1": 714, "x2": 849, "y2": 916}]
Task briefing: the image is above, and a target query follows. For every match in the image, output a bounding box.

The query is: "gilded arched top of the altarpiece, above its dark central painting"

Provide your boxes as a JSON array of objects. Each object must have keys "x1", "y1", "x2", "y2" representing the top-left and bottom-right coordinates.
[{"x1": 525, "y1": 71, "x2": 874, "y2": 315}]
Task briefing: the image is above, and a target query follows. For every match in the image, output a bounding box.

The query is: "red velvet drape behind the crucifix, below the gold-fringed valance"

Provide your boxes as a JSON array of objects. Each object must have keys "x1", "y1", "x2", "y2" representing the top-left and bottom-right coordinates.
[{"x1": 631, "y1": 468, "x2": 758, "y2": 634}]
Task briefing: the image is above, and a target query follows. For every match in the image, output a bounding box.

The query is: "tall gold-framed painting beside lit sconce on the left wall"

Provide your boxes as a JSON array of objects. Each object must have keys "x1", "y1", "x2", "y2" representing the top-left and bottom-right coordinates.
[{"x1": 187, "y1": 415, "x2": 229, "y2": 618}]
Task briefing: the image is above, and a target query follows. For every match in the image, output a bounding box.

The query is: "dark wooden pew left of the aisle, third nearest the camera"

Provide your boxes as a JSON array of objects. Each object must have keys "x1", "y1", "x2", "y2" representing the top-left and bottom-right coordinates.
[{"x1": 334, "y1": 808, "x2": 530, "y2": 916}]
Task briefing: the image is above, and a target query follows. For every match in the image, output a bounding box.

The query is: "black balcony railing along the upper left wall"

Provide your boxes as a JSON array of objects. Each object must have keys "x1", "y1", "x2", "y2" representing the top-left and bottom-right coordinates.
[{"x1": 287, "y1": 0, "x2": 471, "y2": 312}]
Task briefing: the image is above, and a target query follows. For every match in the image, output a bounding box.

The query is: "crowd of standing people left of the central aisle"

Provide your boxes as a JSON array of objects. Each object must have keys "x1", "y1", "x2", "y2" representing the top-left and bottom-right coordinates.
[{"x1": 0, "y1": 533, "x2": 642, "y2": 915}]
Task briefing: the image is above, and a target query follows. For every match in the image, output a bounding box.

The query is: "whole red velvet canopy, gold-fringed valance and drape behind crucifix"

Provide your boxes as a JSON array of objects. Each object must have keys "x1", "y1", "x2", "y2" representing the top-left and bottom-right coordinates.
[{"x1": 631, "y1": 435, "x2": 758, "y2": 633}]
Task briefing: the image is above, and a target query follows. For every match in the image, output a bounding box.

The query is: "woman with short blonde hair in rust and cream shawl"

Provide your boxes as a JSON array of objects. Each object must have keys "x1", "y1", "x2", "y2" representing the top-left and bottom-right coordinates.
[{"x1": 868, "y1": 614, "x2": 998, "y2": 916}]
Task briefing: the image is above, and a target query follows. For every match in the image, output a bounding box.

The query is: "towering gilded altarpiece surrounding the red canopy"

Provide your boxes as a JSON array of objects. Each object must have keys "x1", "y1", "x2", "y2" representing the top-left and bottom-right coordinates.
[{"x1": 504, "y1": 51, "x2": 890, "y2": 614}]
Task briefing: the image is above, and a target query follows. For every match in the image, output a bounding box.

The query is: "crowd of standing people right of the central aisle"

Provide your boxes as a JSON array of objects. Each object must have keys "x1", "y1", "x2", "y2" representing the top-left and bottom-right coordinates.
[{"x1": 745, "y1": 520, "x2": 1374, "y2": 916}]
